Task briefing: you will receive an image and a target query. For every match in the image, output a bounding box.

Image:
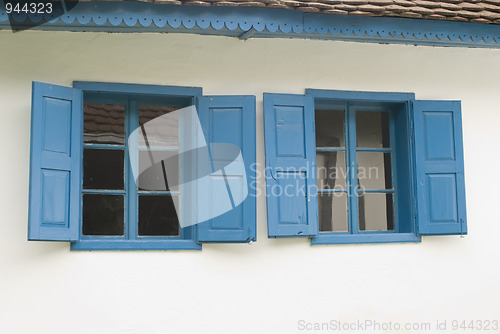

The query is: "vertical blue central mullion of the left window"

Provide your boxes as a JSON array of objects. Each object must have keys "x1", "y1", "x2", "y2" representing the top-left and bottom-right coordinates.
[{"x1": 125, "y1": 100, "x2": 139, "y2": 240}]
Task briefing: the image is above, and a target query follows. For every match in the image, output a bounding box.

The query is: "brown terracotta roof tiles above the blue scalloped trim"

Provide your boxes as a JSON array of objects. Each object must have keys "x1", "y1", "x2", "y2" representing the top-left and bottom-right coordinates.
[{"x1": 87, "y1": 0, "x2": 500, "y2": 24}]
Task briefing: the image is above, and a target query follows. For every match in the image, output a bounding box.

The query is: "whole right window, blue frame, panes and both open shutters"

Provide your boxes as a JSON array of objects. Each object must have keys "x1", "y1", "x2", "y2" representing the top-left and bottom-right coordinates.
[{"x1": 264, "y1": 89, "x2": 467, "y2": 244}]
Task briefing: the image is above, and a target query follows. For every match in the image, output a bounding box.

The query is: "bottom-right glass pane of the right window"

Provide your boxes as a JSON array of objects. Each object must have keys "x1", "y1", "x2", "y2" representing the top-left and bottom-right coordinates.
[{"x1": 358, "y1": 193, "x2": 394, "y2": 231}]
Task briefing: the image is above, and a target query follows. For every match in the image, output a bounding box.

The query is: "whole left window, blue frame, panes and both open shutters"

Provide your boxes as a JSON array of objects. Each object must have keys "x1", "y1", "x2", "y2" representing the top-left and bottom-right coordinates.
[{"x1": 28, "y1": 82, "x2": 256, "y2": 250}]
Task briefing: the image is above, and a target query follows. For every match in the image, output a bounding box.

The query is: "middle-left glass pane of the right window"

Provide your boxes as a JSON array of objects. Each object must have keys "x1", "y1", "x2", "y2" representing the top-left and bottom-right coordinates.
[{"x1": 316, "y1": 152, "x2": 347, "y2": 190}]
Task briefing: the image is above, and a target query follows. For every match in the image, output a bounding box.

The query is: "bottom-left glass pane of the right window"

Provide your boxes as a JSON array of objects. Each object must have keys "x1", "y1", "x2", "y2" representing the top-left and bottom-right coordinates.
[{"x1": 318, "y1": 193, "x2": 349, "y2": 232}]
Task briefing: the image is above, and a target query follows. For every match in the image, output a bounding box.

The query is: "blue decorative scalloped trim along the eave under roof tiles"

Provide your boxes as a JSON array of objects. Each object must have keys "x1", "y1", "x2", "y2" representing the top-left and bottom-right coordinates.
[{"x1": 0, "y1": 2, "x2": 500, "y2": 48}]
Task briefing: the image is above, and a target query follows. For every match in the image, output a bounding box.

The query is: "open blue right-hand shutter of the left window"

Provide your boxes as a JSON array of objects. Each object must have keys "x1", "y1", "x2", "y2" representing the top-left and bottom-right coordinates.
[{"x1": 198, "y1": 96, "x2": 256, "y2": 242}]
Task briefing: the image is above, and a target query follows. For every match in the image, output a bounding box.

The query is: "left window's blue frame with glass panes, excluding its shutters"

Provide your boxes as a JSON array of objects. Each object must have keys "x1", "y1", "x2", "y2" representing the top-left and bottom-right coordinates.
[{"x1": 72, "y1": 93, "x2": 199, "y2": 249}]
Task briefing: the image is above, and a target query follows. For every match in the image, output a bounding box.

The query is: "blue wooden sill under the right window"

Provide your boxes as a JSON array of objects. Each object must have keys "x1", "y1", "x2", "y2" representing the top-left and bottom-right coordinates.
[{"x1": 311, "y1": 233, "x2": 422, "y2": 245}]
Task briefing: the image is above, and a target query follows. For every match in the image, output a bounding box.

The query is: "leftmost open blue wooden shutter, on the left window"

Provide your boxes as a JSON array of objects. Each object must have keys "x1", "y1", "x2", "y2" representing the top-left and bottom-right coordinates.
[{"x1": 28, "y1": 82, "x2": 82, "y2": 241}]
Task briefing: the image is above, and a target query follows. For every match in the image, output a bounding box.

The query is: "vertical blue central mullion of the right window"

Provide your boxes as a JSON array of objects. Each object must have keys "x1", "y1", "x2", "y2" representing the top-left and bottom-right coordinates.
[{"x1": 346, "y1": 105, "x2": 359, "y2": 234}]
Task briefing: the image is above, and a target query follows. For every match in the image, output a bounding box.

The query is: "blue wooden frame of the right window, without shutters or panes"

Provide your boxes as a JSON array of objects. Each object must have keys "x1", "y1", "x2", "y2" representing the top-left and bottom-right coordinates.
[{"x1": 306, "y1": 89, "x2": 420, "y2": 245}]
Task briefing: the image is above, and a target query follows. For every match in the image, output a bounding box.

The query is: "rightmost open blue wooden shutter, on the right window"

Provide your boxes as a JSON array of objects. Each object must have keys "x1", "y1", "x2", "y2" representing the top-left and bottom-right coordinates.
[{"x1": 413, "y1": 101, "x2": 467, "y2": 235}]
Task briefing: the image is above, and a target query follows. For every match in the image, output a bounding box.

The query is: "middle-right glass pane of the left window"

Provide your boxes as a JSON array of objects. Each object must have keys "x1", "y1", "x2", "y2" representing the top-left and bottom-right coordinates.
[{"x1": 137, "y1": 150, "x2": 180, "y2": 191}]
